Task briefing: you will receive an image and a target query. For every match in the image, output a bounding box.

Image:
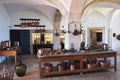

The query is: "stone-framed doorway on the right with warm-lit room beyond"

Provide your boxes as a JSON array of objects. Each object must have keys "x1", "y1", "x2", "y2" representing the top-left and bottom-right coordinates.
[{"x1": 88, "y1": 28, "x2": 104, "y2": 49}]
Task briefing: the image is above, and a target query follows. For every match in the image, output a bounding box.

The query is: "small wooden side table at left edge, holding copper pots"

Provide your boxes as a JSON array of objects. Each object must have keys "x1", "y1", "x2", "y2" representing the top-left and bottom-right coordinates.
[{"x1": 0, "y1": 50, "x2": 17, "y2": 64}]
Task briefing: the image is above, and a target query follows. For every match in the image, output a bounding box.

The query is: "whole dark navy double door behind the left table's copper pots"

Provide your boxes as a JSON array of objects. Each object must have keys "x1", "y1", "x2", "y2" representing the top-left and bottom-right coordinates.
[{"x1": 10, "y1": 30, "x2": 30, "y2": 54}]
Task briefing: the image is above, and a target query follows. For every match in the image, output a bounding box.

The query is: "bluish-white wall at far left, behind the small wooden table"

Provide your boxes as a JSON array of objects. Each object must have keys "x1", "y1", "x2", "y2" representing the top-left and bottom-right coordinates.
[{"x1": 0, "y1": 4, "x2": 10, "y2": 62}]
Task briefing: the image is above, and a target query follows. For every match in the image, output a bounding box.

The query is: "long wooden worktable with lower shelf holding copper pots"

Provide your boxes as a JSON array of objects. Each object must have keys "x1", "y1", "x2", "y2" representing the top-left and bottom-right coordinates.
[{"x1": 39, "y1": 51, "x2": 117, "y2": 77}]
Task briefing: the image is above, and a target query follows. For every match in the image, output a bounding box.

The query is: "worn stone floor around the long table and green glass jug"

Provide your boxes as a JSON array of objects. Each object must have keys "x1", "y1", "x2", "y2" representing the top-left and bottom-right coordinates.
[{"x1": 1, "y1": 55, "x2": 120, "y2": 80}]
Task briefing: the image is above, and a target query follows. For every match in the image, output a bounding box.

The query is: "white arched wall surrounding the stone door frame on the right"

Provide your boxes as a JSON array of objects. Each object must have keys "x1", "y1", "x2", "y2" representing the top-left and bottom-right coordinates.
[{"x1": 83, "y1": 11, "x2": 108, "y2": 44}]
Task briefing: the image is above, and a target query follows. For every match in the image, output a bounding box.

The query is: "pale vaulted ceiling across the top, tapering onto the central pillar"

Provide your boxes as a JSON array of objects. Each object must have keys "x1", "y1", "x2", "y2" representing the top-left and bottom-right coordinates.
[{"x1": 0, "y1": 0, "x2": 120, "y2": 22}]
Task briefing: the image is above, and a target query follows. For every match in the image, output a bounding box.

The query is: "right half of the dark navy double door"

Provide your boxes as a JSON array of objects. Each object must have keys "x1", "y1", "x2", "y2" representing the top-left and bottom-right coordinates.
[{"x1": 20, "y1": 30, "x2": 30, "y2": 54}]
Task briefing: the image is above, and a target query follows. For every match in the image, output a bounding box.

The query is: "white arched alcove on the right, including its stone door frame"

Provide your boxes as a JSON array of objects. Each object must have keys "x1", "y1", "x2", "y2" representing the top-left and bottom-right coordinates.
[{"x1": 83, "y1": 10, "x2": 106, "y2": 45}]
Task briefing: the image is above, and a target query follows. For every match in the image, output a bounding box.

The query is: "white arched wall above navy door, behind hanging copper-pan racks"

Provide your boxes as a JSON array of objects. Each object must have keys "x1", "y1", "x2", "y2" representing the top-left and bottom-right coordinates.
[{"x1": 5, "y1": 4, "x2": 55, "y2": 30}]
